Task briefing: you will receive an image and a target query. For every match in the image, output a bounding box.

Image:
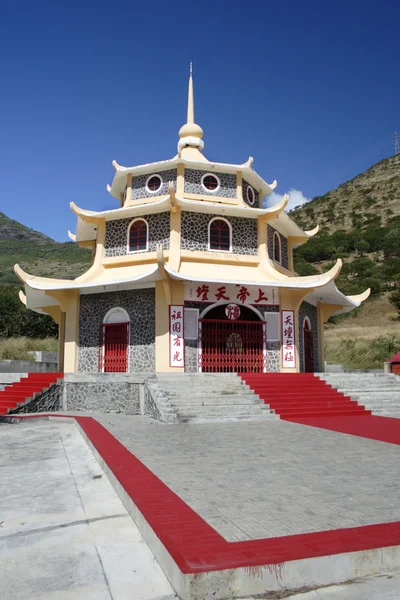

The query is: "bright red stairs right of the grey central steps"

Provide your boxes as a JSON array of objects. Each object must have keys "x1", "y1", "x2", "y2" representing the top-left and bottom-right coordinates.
[{"x1": 240, "y1": 373, "x2": 371, "y2": 421}]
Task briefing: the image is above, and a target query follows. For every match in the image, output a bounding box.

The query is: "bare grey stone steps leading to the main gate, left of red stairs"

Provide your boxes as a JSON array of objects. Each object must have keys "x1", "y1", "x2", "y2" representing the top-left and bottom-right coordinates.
[{"x1": 157, "y1": 373, "x2": 278, "y2": 423}]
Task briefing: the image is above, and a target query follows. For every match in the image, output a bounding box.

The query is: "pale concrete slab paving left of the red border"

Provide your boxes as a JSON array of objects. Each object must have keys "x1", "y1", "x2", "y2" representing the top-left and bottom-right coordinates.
[{"x1": 0, "y1": 419, "x2": 177, "y2": 600}]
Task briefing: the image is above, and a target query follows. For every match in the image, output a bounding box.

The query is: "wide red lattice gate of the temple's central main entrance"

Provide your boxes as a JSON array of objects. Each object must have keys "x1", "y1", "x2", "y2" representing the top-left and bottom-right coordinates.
[{"x1": 199, "y1": 319, "x2": 267, "y2": 373}]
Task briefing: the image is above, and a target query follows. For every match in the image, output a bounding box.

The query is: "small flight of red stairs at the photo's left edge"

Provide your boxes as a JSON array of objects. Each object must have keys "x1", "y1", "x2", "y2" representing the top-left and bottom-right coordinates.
[{"x1": 0, "y1": 373, "x2": 64, "y2": 415}]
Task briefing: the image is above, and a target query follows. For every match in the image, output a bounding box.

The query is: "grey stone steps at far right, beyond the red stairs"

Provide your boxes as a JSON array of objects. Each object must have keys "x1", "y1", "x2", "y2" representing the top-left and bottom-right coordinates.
[{"x1": 319, "y1": 373, "x2": 400, "y2": 418}]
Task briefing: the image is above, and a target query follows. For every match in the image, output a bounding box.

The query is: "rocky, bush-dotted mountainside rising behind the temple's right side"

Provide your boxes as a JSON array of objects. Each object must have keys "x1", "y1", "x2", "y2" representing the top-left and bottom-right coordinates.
[{"x1": 290, "y1": 154, "x2": 400, "y2": 294}]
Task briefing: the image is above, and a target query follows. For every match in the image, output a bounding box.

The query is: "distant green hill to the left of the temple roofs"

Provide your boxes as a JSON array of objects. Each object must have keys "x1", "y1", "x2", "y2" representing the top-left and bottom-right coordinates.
[{"x1": 0, "y1": 213, "x2": 92, "y2": 284}]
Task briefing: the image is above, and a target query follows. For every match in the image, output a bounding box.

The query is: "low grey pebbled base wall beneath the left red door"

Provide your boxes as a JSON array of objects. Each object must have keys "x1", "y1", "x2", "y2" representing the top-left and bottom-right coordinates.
[{"x1": 64, "y1": 380, "x2": 140, "y2": 415}]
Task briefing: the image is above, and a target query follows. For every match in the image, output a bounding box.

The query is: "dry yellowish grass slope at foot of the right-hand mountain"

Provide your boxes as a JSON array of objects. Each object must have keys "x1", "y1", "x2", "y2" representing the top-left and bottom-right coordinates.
[{"x1": 325, "y1": 296, "x2": 400, "y2": 369}]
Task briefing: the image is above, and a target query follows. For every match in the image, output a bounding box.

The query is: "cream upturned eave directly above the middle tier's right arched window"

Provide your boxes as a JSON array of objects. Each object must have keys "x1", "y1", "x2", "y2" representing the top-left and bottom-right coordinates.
[{"x1": 176, "y1": 196, "x2": 288, "y2": 219}]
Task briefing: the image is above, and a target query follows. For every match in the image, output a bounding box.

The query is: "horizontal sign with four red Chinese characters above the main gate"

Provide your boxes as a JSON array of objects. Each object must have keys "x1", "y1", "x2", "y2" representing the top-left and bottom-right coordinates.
[{"x1": 185, "y1": 282, "x2": 279, "y2": 306}]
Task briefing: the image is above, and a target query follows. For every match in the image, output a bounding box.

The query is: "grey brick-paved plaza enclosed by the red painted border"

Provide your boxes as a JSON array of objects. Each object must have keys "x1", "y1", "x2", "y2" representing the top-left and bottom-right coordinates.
[{"x1": 96, "y1": 414, "x2": 400, "y2": 541}]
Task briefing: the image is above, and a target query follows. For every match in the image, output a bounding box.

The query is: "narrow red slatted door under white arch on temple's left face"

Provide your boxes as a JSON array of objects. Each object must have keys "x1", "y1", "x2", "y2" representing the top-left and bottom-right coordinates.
[{"x1": 99, "y1": 323, "x2": 129, "y2": 373}]
